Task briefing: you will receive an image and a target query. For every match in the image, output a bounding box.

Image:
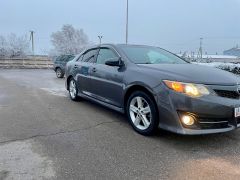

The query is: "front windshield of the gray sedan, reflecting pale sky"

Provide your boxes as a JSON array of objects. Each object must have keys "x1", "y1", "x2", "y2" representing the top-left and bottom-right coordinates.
[{"x1": 121, "y1": 46, "x2": 187, "y2": 64}]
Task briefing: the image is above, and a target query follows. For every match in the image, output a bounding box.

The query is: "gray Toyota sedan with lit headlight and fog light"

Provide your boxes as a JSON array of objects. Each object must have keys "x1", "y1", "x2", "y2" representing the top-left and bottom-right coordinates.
[{"x1": 66, "y1": 44, "x2": 240, "y2": 135}]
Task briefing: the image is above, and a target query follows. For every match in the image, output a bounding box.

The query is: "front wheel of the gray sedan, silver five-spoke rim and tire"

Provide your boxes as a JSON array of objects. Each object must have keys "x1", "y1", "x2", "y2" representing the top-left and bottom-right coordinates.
[{"x1": 126, "y1": 91, "x2": 159, "y2": 136}]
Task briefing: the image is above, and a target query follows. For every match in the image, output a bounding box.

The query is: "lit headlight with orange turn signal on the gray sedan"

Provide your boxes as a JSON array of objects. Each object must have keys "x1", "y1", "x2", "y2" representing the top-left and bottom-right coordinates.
[{"x1": 163, "y1": 80, "x2": 210, "y2": 97}]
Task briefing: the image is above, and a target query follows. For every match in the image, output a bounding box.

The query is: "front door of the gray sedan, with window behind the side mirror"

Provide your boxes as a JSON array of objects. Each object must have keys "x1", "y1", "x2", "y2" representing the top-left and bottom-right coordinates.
[{"x1": 91, "y1": 47, "x2": 124, "y2": 107}]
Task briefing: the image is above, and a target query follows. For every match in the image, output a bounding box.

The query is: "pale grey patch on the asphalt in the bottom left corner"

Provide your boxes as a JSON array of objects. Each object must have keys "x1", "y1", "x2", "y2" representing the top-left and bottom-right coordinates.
[{"x1": 0, "y1": 141, "x2": 55, "y2": 180}]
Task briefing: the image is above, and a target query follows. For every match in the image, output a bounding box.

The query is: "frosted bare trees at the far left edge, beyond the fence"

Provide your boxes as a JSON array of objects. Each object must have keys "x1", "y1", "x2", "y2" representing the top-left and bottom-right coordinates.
[{"x1": 0, "y1": 34, "x2": 29, "y2": 57}]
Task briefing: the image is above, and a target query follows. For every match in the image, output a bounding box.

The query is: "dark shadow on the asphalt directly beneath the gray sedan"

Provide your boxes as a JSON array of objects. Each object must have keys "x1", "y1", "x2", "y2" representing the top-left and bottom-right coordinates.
[{"x1": 79, "y1": 97, "x2": 240, "y2": 151}]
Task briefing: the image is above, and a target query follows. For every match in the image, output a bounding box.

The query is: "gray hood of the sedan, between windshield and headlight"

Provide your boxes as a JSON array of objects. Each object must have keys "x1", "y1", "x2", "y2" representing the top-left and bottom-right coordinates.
[{"x1": 139, "y1": 64, "x2": 240, "y2": 85}]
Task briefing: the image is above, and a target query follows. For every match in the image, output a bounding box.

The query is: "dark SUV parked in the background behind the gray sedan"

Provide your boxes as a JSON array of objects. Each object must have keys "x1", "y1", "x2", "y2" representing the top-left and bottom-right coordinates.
[{"x1": 53, "y1": 55, "x2": 75, "y2": 78}]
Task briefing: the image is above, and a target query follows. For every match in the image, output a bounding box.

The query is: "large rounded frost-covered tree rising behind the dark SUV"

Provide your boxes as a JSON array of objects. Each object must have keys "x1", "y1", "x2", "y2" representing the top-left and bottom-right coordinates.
[{"x1": 51, "y1": 25, "x2": 90, "y2": 54}]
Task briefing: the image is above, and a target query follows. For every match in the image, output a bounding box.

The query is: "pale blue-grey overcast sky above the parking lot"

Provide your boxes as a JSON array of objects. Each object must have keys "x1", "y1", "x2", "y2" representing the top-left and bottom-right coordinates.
[{"x1": 0, "y1": 0, "x2": 240, "y2": 53}]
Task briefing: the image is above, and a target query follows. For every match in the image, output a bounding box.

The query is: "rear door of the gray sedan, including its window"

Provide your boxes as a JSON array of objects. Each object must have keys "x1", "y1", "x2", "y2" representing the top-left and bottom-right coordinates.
[{"x1": 74, "y1": 48, "x2": 98, "y2": 95}]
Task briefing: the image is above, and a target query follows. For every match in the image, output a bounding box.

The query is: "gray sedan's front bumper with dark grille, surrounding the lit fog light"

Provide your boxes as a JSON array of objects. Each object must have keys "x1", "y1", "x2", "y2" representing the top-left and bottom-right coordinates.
[{"x1": 157, "y1": 85, "x2": 240, "y2": 135}]
